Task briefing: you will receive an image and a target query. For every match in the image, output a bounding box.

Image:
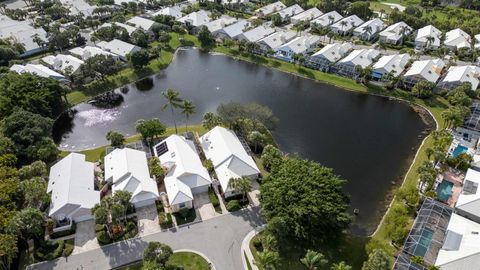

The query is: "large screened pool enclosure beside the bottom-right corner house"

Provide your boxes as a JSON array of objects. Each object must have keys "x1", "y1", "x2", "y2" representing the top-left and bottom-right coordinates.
[{"x1": 403, "y1": 197, "x2": 453, "y2": 264}]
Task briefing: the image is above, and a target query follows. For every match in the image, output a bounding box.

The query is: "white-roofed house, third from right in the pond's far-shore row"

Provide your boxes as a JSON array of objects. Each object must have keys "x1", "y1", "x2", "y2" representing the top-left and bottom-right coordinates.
[{"x1": 372, "y1": 53, "x2": 410, "y2": 81}]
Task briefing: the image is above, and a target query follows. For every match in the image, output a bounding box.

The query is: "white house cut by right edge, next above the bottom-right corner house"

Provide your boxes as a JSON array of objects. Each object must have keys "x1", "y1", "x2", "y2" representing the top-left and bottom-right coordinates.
[{"x1": 455, "y1": 169, "x2": 480, "y2": 223}]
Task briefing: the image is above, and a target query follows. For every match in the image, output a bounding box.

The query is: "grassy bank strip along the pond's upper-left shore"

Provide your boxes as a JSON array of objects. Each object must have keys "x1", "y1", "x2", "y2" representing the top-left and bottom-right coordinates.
[{"x1": 67, "y1": 33, "x2": 198, "y2": 105}]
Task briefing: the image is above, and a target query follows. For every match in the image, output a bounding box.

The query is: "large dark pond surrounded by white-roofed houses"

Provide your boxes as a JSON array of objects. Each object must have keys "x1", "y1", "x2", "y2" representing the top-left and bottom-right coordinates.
[{"x1": 55, "y1": 49, "x2": 426, "y2": 234}]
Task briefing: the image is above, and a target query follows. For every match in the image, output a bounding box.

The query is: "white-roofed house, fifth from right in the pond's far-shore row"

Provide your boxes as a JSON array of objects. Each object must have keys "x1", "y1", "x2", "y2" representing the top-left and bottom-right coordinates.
[{"x1": 307, "y1": 42, "x2": 353, "y2": 72}]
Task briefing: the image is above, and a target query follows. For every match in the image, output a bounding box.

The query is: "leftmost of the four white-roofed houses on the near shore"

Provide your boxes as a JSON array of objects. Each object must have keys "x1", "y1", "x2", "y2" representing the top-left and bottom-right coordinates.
[{"x1": 47, "y1": 153, "x2": 100, "y2": 227}]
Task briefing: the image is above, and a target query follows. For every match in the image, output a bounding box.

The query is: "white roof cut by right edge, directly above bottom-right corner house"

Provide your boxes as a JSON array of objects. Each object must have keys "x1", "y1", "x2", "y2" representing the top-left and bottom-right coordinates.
[{"x1": 455, "y1": 169, "x2": 480, "y2": 217}]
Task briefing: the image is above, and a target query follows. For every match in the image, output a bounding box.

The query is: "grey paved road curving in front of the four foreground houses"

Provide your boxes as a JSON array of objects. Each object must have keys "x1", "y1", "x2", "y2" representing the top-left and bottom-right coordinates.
[{"x1": 27, "y1": 207, "x2": 263, "y2": 270}]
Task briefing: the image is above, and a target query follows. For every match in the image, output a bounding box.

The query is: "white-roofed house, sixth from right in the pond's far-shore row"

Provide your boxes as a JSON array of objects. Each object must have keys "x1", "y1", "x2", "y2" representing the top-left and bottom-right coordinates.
[{"x1": 275, "y1": 35, "x2": 320, "y2": 62}]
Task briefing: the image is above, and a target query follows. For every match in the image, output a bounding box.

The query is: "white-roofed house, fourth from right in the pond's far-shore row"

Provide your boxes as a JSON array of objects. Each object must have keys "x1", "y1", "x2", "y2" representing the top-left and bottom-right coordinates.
[{"x1": 333, "y1": 49, "x2": 380, "y2": 77}]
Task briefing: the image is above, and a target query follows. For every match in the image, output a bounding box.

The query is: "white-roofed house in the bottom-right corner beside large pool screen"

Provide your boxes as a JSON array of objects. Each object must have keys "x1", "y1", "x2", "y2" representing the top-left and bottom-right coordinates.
[{"x1": 435, "y1": 213, "x2": 480, "y2": 270}]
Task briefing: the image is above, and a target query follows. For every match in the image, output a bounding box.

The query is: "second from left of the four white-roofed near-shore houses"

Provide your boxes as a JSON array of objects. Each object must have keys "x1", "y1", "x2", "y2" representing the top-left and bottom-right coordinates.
[{"x1": 104, "y1": 148, "x2": 159, "y2": 208}]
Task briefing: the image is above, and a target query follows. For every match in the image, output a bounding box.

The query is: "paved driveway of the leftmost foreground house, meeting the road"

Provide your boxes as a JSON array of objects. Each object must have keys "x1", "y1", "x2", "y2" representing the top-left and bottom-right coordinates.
[{"x1": 72, "y1": 220, "x2": 100, "y2": 255}]
